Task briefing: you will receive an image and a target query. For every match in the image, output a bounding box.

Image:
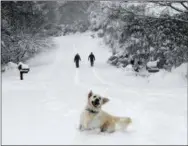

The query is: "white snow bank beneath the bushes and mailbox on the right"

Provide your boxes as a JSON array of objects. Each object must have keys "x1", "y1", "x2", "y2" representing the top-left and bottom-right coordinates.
[{"x1": 122, "y1": 63, "x2": 188, "y2": 88}]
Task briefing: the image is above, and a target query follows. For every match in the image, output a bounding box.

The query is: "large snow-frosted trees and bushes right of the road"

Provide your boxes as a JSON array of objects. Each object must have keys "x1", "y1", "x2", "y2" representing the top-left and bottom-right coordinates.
[{"x1": 90, "y1": 2, "x2": 188, "y2": 71}]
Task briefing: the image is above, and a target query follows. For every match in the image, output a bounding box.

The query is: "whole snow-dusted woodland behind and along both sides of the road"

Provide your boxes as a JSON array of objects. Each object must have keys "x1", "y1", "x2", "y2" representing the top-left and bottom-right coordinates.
[{"x1": 1, "y1": 1, "x2": 188, "y2": 70}]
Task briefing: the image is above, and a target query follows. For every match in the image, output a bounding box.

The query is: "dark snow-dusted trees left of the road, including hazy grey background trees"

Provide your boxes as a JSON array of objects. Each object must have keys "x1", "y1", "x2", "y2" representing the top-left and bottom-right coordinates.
[{"x1": 1, "y1": 1, "x2": 91, "y2": 65}]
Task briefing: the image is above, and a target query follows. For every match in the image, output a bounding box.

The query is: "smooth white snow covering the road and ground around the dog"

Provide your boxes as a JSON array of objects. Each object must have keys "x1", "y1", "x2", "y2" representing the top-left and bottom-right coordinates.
[{"x1": 2, "y1": 33, "x2": 187, "y2": 145}]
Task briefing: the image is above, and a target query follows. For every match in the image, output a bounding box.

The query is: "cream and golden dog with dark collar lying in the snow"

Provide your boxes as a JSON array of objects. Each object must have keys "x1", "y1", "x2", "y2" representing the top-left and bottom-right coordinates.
[{"x1": 79, "y1": 91, "x2": 132, "y2": 132}]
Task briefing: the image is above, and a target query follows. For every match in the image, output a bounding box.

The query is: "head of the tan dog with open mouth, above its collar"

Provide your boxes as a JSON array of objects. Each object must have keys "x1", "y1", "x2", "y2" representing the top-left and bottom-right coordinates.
[{"x1": 88, "y1": 91, "x2": 109, "y2": 108}]
